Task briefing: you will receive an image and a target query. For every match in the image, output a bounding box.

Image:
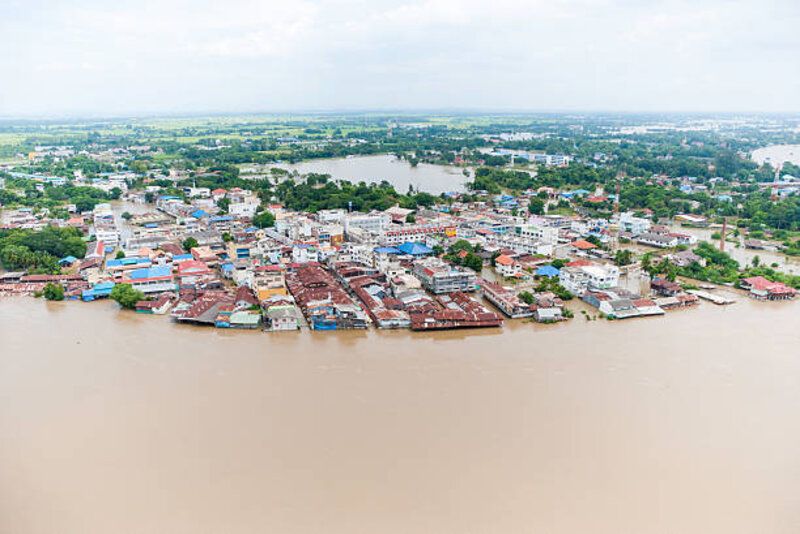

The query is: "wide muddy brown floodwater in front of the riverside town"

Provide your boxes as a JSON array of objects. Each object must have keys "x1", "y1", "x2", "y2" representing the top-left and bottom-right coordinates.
[{"x1": 0, "y1": 297, "x2": 800, "y2": 534}]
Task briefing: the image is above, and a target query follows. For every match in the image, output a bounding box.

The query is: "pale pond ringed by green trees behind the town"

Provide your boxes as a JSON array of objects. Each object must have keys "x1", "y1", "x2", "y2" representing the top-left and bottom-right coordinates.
[{"x1": 272, "y1": 154, "x2": 469, "y2": 195}]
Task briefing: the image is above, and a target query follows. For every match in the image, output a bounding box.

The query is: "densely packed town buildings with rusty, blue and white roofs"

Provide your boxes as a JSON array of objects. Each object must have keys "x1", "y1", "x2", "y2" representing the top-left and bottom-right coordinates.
[{"x1": 0, "y1": 164, "x2": 795, "y2": 331}]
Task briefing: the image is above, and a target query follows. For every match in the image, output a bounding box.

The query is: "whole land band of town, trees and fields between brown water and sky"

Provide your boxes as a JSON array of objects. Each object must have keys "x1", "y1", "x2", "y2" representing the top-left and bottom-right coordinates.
[{"x1": 0, "y1": 116, "x2": 800, "y2": 331}]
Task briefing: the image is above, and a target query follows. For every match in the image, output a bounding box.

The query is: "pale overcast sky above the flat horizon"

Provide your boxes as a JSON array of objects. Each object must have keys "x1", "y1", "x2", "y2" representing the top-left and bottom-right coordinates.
[{"x1": 0, "y1": 0, "x2": 800, "y2": 116}]
